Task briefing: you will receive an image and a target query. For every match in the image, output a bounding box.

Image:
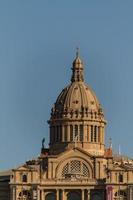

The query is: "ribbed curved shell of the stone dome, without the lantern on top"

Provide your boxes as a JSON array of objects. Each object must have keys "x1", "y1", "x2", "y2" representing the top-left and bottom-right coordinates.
[{"x1": 55, "y1": 82, "x2": 100, "y2": 118}]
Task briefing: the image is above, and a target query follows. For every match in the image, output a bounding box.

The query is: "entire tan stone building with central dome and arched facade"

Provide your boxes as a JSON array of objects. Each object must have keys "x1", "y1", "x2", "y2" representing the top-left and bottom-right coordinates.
[{"x1": 1, "y1": 52, "x2": 133, "y2": 200}]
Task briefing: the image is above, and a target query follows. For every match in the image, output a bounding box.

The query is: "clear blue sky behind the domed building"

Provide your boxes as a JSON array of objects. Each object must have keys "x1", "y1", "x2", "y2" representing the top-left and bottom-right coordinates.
[{"x1": 0, "y1": 0, "x2": 133, "y2": 169}]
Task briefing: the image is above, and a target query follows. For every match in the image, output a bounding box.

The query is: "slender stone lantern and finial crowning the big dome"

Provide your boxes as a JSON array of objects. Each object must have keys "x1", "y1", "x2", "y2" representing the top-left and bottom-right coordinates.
[{"x1": 71, "y1": 48, "x2": 84, "y2": 82}]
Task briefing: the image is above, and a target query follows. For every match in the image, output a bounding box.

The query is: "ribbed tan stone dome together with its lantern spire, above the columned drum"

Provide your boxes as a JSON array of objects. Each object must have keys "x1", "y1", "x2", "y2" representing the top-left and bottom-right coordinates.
[{"x1": 52, "y1": 54, "x2": 102, "y2": 118}]
